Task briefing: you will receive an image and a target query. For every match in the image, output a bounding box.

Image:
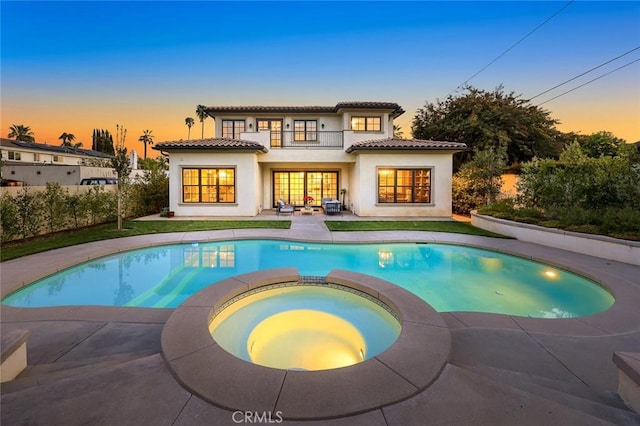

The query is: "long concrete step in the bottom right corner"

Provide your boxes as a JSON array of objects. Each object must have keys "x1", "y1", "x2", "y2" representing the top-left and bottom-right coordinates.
[{"x1": 456, "y1": 364, "x2": 640, "y2": 426}]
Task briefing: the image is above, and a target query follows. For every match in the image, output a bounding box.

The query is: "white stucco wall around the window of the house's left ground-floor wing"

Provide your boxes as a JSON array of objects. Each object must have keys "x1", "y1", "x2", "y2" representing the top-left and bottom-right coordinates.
[{"x1": 169, "y1": 151, "x2": 261, "y2": 216}]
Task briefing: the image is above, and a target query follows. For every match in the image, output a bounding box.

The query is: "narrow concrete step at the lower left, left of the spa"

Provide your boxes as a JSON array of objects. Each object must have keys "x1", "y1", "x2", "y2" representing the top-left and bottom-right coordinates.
[{"x1": 2, "y1": 352, "x2": 157, "y2": 394}]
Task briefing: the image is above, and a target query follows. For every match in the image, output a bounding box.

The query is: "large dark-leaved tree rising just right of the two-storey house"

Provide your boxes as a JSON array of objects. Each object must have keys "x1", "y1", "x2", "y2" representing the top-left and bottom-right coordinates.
[{"x1": 411, "y1": 86, "x2": 562, "y2": 164}]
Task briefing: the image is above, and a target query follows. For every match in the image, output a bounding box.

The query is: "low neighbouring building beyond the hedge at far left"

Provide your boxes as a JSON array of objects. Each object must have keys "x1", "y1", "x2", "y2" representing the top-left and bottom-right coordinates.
[{"x1": 0, "y1": 138, "x2": 115, "y2": 186}]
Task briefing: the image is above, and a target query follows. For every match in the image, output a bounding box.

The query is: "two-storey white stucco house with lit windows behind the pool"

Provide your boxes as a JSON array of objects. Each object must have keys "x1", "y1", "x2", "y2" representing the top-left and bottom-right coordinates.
[{"x1": 153, "y1": 102, "x2": 466, "y2": 217}]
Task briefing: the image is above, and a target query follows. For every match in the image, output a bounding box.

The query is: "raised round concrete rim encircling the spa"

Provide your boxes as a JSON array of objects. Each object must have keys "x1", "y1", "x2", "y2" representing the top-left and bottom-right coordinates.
[{"x1": 161, "y1": 268, "x2": 451, "y2": 420}]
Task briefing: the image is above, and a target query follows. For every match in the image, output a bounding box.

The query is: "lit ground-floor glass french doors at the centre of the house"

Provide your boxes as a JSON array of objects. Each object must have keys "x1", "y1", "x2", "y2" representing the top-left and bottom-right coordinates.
[{"x1": 273, "y1": 171, "x2": 338, "y2": 206}]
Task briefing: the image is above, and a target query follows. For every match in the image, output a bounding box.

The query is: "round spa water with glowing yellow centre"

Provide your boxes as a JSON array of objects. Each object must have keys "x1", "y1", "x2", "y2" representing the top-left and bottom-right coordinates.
[{"x1": 209, "y1": 283, "x2": 401, "y2": 371}]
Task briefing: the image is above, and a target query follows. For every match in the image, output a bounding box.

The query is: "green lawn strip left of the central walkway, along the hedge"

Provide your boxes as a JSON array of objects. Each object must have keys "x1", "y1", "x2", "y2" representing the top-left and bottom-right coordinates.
[{"x1": 0, "y1": 220, "x2": 291, "y2": 261}]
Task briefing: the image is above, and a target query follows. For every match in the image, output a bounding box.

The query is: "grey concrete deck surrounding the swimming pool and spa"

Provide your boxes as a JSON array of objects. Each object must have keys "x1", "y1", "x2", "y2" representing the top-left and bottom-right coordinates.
[{"x1": 0, "y1": 215, "x2": 640, "y2": 426}]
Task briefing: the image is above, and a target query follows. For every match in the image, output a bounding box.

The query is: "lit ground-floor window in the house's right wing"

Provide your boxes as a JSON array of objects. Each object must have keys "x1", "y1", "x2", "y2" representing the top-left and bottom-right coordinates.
[{"x1": 378, "y1": 168, "x2": 431, "y2": 203}]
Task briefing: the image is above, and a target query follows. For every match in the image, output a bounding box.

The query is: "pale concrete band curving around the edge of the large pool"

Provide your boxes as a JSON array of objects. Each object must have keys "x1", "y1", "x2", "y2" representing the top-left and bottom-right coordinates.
[{"x1": 0, "y1": 229, "x2": 640, "y2": 336}]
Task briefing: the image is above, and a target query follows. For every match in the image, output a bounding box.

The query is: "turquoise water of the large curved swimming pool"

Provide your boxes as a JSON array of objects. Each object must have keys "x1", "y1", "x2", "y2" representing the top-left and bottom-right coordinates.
[{"x1": 2, "y1": 240, "x2": 614, "y2": 318}]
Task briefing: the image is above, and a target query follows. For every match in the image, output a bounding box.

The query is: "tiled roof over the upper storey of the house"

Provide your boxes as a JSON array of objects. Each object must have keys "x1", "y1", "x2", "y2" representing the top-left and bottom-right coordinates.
[{"x1": 205, "y1": 101, "x2": 404, "y2": 118}]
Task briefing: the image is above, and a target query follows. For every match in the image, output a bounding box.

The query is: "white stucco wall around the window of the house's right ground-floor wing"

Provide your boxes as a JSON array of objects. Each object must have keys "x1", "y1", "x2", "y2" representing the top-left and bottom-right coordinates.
[{"x1": 350, "y1": 151, "x2": 453, "y2": 217}]
